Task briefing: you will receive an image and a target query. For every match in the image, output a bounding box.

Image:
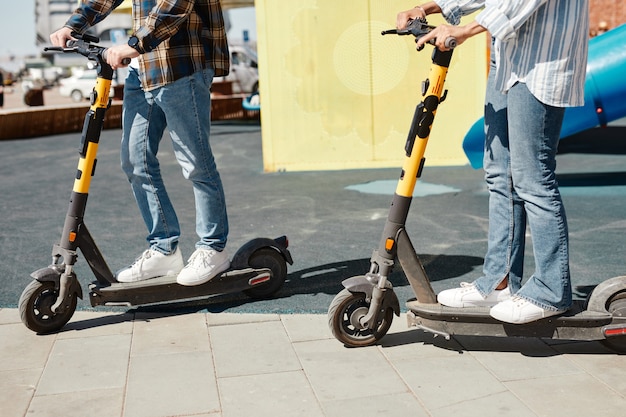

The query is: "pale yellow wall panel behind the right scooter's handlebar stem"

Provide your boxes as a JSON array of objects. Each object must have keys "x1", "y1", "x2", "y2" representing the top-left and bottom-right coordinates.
[{"x1": 255, "y1": 0, "x2": 486, "y2": 172}]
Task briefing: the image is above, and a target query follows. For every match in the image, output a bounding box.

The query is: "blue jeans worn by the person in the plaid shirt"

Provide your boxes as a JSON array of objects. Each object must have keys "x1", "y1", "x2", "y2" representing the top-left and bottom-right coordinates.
[{"x1": 121, "y1": 68, "x2": 228, "y2": 254}]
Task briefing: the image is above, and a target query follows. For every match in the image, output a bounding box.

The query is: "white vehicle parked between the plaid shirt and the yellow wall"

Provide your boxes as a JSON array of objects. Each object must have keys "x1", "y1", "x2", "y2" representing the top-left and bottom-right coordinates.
[{"x1": 213, "y1": 45, "x2": 259, "y2": 93}]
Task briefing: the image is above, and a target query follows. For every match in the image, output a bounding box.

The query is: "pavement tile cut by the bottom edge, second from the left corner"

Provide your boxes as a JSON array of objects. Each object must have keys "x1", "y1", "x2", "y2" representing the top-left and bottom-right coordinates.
[{"x1": 28, "y1": 388, "x2": 124, "y2": 417}]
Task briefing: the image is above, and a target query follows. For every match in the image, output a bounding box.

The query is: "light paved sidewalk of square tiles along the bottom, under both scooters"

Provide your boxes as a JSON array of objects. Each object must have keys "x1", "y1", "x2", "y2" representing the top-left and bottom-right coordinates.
[{"x1": 0, "y1": 308, "x2": 626, "y2": 417}]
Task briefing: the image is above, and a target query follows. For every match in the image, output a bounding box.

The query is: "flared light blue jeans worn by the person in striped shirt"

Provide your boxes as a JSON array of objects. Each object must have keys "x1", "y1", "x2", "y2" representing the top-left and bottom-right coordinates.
[{"x1": 475, "y1": 62, "x2": 572, "y2": 310}]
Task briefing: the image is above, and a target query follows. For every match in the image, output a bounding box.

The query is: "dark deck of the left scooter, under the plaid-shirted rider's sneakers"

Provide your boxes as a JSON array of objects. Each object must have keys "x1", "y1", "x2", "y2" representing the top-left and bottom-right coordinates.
[{"x1": 89, "y1": 268, "x2": 272, "y2": 307}]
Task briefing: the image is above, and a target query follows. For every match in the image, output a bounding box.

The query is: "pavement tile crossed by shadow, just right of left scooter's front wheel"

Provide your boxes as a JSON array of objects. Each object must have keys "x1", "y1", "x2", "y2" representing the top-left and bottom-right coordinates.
[{"x1": 58, "y1": 311, "x2": 135, "y2": 339}]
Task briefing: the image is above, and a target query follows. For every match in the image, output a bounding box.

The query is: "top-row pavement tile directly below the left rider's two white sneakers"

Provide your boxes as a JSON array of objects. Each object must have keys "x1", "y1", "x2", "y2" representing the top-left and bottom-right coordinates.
[{"x1": 131, "y1": 313, "x2": 211, "y2": 356}]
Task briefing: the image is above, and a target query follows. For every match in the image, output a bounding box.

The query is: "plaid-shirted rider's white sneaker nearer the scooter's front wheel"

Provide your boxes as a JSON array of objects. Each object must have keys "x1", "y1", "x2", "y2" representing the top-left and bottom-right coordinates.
[{"x1": 115, "y1": 248, "x2": 184, "y2": 282}]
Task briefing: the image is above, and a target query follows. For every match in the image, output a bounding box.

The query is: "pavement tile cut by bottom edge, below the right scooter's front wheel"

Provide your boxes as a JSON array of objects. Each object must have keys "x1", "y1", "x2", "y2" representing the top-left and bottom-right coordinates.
[{"x1": 322, "y1": 393, "x2": 426, "y2": 417}]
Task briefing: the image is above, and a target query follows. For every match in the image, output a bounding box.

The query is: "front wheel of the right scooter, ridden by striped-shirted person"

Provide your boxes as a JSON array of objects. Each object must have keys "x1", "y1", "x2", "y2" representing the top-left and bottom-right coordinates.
[{"x1": 328, "y1": 289, "x2": 393, "y2": 347}]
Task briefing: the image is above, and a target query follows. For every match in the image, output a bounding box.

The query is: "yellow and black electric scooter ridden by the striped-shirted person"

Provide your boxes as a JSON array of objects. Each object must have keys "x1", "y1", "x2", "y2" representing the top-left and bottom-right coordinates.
[{"x1": 328, "y1": 20, "x2": 626, "y2": 352}]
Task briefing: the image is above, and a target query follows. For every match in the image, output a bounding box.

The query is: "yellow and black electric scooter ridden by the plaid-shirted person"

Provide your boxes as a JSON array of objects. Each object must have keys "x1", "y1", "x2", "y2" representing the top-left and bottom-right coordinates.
[{"x1": 18, "y1": 33, "x2": 293, "y2": 333}]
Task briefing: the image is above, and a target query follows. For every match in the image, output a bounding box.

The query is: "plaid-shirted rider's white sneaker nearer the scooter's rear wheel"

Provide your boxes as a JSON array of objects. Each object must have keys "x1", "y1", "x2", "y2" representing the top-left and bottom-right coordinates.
[{"x1": 176, "y1": 249, "x2": 230, "y2": 285}]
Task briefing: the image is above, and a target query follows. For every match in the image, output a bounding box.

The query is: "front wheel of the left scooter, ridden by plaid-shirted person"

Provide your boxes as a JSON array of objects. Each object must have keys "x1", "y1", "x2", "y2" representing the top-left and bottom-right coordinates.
[{"x1": 18, "y1": 280, "x2": 78, "y2": 333}]
